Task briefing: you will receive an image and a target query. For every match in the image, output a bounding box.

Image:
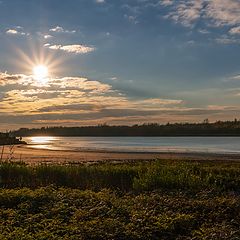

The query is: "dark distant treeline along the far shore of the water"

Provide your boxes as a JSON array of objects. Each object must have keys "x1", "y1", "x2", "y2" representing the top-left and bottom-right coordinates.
[{"x1": 12, "y1": 120, "x2": 240, "y2": 136}]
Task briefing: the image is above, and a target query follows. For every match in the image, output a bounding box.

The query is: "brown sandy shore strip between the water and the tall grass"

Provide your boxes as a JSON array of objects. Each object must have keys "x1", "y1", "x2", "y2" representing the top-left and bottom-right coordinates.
[{"x1": 0, "y1": 145, "x2": 240, "y2": 164}]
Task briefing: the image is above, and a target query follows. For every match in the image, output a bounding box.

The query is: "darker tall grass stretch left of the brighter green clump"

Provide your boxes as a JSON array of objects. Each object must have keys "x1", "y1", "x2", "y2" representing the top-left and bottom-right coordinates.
[{"x1": 0, "y1": 163, "x2": 138, "y2": 191}]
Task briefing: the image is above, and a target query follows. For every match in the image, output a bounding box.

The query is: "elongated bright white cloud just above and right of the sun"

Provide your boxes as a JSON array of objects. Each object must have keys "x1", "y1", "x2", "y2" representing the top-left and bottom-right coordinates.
[{"x1": 44, "y1": 43, "x2": 95, "y2": 54}]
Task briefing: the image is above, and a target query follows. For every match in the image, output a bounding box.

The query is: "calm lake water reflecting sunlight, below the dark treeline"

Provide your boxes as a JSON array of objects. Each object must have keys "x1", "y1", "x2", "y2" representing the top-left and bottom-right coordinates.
[{"x1": 23, "y1": 136, "x2": 240, "y2": 154}]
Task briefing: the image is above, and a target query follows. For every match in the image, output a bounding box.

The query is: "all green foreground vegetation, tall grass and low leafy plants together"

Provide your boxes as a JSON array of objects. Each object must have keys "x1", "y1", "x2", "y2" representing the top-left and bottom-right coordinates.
[{"x1": 0, "y1": 161, "x2": 240, "y2": 240}]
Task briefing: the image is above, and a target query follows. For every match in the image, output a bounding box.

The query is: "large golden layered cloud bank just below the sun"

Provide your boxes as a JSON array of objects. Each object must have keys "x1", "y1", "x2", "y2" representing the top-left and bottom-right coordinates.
[{"x1": 0, "y1": 70, "x2": 240, "y2": 128}]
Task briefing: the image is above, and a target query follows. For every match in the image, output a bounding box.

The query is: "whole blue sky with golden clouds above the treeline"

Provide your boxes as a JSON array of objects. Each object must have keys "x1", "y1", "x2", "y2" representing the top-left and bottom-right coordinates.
[{"x1": 0, "y1": 0, "x2": 240, "y2": 130}]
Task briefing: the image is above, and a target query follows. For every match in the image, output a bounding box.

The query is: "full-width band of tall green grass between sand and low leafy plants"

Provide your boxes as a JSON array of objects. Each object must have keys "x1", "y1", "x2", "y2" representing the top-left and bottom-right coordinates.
[{"x1": 0, "y1": 160, "x2": 240, "y2": 192}]
